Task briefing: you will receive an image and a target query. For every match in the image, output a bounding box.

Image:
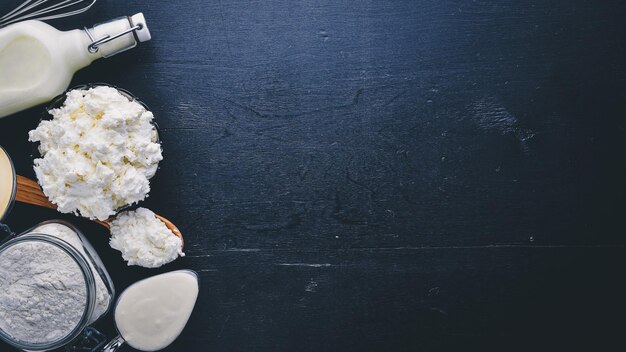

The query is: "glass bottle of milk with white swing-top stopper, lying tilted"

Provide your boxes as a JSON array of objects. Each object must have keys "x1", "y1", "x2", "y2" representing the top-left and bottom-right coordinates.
[{"x1": 0, "y1": 13, "x2": 150, "y2": 118}]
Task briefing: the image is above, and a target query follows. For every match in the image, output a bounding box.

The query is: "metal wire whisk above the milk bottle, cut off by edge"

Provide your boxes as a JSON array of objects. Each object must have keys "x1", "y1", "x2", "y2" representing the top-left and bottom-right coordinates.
[{"x1": 0, "y1": 0, "x2": 97, "y2": 27}]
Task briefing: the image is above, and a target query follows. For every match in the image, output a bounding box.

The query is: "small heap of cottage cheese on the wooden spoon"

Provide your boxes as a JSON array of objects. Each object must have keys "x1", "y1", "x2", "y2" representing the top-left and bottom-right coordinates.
[{"x1": 110, "y1": 208, "x2": 185, "y2": 268}]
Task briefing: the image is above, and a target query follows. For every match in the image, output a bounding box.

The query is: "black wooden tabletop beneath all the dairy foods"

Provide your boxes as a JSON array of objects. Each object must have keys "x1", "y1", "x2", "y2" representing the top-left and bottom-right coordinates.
[{"x1": 0, "y1": 0, "x2": 626, "y2": 351}]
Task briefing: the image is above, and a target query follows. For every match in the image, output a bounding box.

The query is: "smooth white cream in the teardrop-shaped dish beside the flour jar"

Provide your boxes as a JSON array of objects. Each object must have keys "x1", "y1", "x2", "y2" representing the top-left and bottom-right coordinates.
[{"x1": 115, "y1": 270, "x2": 199, "y2": 351}]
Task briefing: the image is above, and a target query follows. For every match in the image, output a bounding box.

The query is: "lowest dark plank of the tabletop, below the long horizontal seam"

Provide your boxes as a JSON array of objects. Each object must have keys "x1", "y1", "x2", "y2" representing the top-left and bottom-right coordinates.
[{"x1": 129, "y1": 246, "x2": 626, "y2": 351}]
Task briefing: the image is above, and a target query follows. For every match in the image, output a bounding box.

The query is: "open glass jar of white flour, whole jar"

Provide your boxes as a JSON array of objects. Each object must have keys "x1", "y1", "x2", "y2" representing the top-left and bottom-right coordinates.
[{"x1": 0, "y1": 220, "x2": 115, "y2": 351}]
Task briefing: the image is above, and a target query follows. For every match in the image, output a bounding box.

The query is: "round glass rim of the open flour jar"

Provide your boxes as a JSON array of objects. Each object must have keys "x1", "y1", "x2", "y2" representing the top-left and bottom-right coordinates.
[{"x1": 0, "y1": 232, "x2": 96, "y2": 351}]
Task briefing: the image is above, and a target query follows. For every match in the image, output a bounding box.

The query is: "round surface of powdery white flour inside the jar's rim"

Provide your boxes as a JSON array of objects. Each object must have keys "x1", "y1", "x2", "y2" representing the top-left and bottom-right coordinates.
[{"x1": 0, "y1": 242, "x2": 87, "y2": 343}]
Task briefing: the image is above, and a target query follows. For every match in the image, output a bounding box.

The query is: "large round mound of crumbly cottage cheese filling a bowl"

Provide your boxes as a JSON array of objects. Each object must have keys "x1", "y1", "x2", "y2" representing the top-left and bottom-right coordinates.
[{"x1": 29, "y1": 86, "x2": 163, "y2": 220}]
